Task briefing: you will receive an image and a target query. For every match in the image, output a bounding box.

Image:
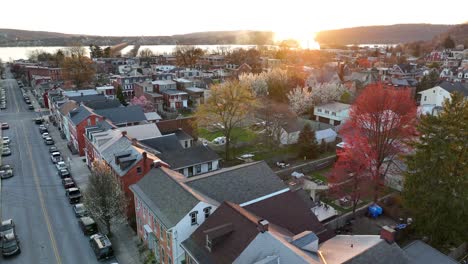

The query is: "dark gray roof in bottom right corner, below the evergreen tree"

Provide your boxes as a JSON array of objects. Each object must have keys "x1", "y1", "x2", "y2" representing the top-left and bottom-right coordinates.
[{"x1": 403, "y1": 240, "x2": 458, "y2": 264}]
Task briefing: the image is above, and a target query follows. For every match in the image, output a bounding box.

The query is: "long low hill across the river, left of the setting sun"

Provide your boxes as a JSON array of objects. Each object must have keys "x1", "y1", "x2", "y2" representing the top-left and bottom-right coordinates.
[{"x1": 0, "y1": 29, "x2": 273, "y2": 47}]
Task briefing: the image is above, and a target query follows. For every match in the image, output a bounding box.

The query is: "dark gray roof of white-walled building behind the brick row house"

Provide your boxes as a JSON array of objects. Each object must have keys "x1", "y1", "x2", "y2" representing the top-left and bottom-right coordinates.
[{"x1": 158, "y1": 144, "x2": 221, "y2": 170}]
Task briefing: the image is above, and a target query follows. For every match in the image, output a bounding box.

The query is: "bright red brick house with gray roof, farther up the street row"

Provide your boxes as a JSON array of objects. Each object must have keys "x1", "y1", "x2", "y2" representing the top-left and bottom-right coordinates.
[{"x1": 67, "y1": 105, "x2": 104, "y2": 156}]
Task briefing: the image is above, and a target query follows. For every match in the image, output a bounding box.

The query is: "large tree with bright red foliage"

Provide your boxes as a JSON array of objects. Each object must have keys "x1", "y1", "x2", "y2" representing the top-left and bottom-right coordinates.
[{"x1": 330, "y1": 85, "x2": 416, "y2": 202}]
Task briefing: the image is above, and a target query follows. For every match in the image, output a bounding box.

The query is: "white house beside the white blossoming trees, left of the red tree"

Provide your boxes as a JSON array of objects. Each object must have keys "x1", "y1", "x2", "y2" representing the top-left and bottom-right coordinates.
[{"x1": 314, "y1": 102, "x2": 351, "y2": 126}]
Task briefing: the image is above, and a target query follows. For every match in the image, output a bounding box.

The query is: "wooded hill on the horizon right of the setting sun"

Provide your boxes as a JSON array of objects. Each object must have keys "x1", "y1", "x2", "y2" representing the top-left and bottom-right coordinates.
[{"x1": 315, "y1": 24, "x2": 454, "y2": 45}]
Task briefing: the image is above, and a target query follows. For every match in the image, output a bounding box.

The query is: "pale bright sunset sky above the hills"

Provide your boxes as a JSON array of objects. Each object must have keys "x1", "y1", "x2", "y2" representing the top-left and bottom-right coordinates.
[{"x1": 0, "y1": 0, "x2": 468, "y2": 40}]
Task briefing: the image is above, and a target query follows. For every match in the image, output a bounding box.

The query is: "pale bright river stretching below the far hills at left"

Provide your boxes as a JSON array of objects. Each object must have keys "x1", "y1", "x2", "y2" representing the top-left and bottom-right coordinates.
[{"x1": 0, "y1": 45, "x2": 255, "y2": 62}]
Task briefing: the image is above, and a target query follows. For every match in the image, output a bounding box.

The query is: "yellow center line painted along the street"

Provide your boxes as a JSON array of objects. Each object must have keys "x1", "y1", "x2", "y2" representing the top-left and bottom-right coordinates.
[{"x1": 21, "y1": 122, "x2": 62, "y2": 264}]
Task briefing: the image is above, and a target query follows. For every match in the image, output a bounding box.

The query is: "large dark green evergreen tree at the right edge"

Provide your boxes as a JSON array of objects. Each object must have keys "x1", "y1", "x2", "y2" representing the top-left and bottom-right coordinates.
[{"x1": 403, "y1": 93, "x2": 468, "y2": 246}]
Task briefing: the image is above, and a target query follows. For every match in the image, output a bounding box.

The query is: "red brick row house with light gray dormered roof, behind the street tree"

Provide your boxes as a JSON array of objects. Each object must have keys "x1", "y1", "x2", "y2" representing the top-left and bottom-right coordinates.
[{"x1": 85, "y1": 127, "x2": 166, "y2": 220}]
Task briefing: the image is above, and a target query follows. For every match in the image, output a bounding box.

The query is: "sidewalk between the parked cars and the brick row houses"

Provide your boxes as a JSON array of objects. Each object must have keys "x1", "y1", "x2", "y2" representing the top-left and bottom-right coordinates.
[{"x1": 48, "y1": 120, "x2": 142, "y2": 264}]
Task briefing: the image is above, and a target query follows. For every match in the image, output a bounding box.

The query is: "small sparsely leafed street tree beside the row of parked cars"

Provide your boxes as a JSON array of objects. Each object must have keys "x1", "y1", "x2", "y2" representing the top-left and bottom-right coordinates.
[{"x1": 84, "y1": 161, "x2": 127, "y2": 234}]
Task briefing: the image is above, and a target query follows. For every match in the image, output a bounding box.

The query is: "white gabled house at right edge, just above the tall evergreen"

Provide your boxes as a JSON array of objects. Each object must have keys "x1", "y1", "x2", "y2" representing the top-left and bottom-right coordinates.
[{"x1": 419, "y1": 81, "x2": 468, "y2": 114}]
